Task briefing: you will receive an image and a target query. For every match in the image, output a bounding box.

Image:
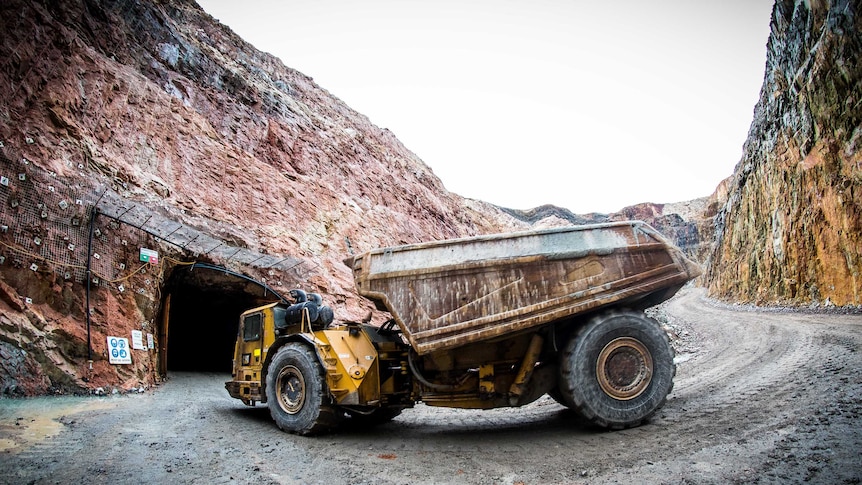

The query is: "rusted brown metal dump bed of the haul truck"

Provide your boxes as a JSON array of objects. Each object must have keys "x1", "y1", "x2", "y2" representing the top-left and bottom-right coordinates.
[{"x1": 348, "y1": 221, "x2": 700, "y2": 354}]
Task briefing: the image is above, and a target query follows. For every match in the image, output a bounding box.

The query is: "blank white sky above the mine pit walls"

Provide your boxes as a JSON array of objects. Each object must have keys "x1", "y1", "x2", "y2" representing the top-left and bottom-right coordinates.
[{"x1": 198, "y1": 0, "x2": 772, "y2": 213}]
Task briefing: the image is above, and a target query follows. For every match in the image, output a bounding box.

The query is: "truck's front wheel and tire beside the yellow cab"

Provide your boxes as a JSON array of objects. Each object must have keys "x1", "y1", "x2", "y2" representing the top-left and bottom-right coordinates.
[{"x1": 266, "y1": 342, "x2": 340, "y2": 435}]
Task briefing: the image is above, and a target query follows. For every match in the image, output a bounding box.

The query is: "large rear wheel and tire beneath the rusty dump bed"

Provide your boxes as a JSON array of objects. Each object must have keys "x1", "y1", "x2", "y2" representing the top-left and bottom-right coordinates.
[{"x1": 559, "y1": 311, "x2": 676, "y2": 429}]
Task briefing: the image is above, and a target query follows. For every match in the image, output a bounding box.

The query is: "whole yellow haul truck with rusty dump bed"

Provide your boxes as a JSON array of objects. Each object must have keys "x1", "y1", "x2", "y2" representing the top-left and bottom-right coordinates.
[{"x1": 225, "y1": 221, "x2": 700, "y2": 435}]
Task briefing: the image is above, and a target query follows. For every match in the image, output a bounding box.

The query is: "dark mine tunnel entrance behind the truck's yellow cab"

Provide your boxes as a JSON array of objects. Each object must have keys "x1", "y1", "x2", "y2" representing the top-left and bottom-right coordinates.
[{"x1": 159, "y1": 263, "x2": 279, "y2": 374}]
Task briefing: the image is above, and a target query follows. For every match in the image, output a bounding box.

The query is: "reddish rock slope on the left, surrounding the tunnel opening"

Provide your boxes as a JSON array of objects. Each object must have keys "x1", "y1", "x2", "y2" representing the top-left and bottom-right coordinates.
[{"x1": 0, "y1": 0, "x2": 528, "y2": 394}]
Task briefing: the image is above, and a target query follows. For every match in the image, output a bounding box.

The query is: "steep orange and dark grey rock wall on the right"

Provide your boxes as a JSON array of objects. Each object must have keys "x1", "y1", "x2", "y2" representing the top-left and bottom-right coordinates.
[{"x1": 707, "y1": 0, "x2": 862, "y2": 306}]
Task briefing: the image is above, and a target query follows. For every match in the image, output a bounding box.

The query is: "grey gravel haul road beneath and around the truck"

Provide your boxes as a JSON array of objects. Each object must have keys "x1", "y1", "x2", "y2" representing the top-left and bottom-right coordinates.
[{"x1": 0, "y1": 290, "x2": 862, "y2": 484}]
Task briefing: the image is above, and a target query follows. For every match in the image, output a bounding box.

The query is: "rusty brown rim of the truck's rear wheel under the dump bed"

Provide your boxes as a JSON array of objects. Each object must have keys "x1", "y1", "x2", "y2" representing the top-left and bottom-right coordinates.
[{"x1": 596, "y1": 337, "x2": 653, "y2": 401}]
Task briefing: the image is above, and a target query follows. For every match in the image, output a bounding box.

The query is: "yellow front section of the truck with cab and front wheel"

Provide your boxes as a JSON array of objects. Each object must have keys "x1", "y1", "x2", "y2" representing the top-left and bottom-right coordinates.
[{"x1": 225, "y1": 290, "x2": 413, "y2": 434}]
